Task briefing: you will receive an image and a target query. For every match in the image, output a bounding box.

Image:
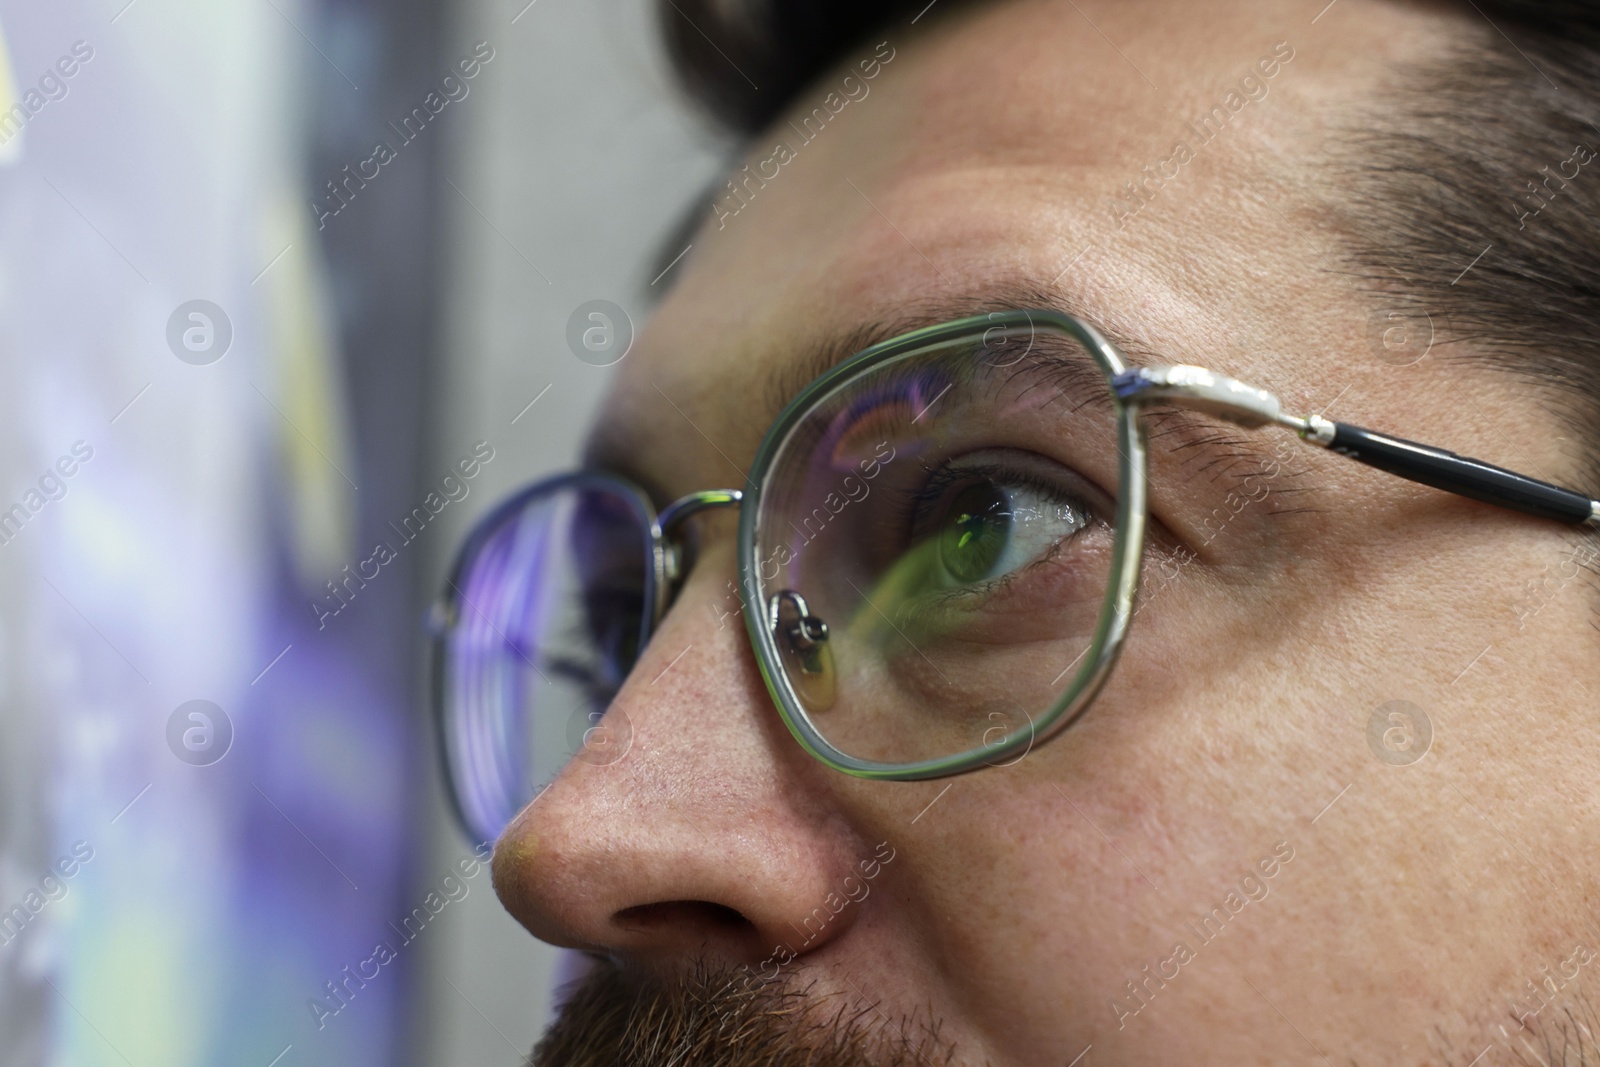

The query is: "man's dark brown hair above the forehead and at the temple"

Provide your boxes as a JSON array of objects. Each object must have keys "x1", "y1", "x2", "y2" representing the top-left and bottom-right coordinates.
[{"x1": 661, "y1": 0, "x2": 1600, "y2": 485}]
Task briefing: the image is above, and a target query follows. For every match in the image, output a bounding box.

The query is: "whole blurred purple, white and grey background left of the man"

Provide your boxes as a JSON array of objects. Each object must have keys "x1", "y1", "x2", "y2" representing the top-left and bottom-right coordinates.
[{"x1": 0, "y1": 0, "x2": 730, "y2": 1067}]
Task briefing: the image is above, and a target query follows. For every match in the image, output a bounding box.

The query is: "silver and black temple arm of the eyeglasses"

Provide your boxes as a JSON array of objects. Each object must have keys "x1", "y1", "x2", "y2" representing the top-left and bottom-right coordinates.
[{"x1": 1112, "y1": 365, "x2": 1600, "y2": 525}]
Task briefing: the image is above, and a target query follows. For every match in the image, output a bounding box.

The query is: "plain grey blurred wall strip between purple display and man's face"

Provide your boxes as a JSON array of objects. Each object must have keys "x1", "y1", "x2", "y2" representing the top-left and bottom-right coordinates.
[{"x1": 414, "y1": 0, "x2": 726, "y2": 1067}]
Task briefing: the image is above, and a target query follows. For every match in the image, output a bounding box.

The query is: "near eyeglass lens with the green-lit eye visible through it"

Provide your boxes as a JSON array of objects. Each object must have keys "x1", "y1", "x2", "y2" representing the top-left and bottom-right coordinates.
[{"x1": 746, "y1": 326, "x2": 1118, "y2": 765}]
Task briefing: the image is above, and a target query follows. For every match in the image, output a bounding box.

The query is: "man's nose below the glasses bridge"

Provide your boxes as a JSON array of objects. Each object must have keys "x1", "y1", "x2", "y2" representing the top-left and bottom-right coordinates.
[{"x1": 493, "y1": 545, "x2": 870, "y2": 963}]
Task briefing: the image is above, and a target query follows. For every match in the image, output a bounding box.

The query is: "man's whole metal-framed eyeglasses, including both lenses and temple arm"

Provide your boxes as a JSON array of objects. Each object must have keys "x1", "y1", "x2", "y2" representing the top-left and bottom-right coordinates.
[{"x1": 430, "y1": 310, "x2": 1600, "y2": 840}]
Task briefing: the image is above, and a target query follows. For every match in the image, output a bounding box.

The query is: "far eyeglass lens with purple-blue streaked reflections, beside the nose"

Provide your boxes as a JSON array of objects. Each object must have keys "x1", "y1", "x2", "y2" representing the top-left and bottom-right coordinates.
[{"x1": 440, "y1": 477, "x2": 653, "y2": 840}]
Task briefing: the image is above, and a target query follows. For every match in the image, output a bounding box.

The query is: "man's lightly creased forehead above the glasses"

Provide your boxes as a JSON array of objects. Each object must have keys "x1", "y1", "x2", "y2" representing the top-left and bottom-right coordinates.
[{"x1": 590, "y1": 0, "x2": 1459, "y2": 494}]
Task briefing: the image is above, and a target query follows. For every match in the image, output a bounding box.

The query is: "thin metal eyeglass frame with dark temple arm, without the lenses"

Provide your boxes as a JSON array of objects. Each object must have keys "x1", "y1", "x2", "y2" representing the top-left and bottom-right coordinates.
[{"x1": 430, "y1": 309, "x2": 1600, "y2": 793}]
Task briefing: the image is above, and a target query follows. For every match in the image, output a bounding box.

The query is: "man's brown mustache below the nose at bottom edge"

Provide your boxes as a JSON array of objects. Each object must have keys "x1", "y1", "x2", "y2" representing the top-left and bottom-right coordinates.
[{"x1": 528, "y1": 961, "x2": 957, "y2": 1067}]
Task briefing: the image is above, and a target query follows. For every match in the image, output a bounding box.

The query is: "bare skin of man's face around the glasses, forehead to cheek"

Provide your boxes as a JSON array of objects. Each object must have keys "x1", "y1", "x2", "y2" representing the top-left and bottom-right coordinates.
[{"x1": 494, "y1": 0, "x2": 1600, "y2": 1065}]
